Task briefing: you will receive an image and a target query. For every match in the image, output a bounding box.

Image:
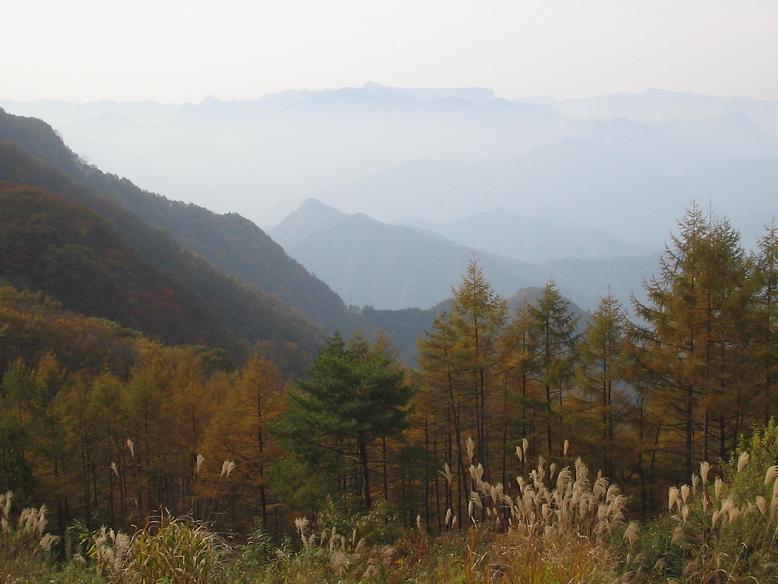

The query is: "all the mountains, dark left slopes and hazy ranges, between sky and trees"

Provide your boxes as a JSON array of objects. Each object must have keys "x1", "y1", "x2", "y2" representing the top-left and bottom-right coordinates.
[{"x1": 0, "y1": 84, "x2": 778, "y2": 364}]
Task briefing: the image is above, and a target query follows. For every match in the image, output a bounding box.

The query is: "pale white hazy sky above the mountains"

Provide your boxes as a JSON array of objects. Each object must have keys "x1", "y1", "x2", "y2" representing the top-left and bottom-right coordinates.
[{"x1": 0, "y1": 0, "x2": 778, "y2": 102}]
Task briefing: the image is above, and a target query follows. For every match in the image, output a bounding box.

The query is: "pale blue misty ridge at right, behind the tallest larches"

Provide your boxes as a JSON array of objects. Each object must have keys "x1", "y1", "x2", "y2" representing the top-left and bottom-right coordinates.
[{"x1": 319, "y1": 115, "x2": 778, "y2": 247}]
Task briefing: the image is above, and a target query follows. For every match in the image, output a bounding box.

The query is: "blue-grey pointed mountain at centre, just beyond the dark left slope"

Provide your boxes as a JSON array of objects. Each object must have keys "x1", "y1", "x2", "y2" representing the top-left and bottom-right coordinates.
[{"x1": 271, "y1": 200, "x2": 530, "y2": 309}]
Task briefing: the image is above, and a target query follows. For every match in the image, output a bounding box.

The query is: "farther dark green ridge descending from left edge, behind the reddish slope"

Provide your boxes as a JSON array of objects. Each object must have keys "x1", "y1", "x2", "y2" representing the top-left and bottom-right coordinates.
[{"x1": 0, "y1": 106, "x2": 355, "y2": 330}]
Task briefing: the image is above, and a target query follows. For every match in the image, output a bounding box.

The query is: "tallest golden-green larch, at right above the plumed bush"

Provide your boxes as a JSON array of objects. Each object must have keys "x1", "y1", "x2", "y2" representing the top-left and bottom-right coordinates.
[{"x1": 632, "y1": 205, "x2": 753, "y2": 481}]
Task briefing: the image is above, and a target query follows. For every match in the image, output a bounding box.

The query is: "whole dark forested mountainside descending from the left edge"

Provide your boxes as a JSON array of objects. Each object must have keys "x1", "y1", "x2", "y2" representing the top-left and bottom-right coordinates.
[{"x1": 0, "y1": 104, "x2": 600, "y2": 360}]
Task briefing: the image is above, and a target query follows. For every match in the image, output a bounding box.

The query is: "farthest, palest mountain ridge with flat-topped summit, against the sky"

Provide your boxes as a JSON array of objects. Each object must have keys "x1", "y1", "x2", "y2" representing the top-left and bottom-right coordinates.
[{"x1": 0, "y1": 83, "x2": 589, "y2": 225}]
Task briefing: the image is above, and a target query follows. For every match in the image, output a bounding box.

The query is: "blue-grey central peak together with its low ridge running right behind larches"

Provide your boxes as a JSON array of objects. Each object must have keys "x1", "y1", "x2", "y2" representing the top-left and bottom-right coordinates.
[{"x1": 271, "y1": 200, "x2": 656, "y2": 309}]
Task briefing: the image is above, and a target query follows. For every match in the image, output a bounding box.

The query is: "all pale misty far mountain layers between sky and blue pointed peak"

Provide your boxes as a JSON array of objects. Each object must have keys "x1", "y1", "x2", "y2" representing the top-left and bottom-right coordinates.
[{"x1": 0, "y1": 83, "x2": 778, "y2": 245}]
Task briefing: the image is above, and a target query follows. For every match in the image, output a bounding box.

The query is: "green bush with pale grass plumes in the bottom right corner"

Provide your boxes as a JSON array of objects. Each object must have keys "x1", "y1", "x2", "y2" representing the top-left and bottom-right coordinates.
[{"x1": 634, "y1": 422, "x2": 778, "y2": 582}]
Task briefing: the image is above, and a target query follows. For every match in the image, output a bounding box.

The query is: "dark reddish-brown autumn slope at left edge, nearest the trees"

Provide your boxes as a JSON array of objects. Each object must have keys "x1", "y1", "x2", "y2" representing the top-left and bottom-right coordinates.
[{"x1": 0, "y1": 184, "x2": 230, "y2": 345}]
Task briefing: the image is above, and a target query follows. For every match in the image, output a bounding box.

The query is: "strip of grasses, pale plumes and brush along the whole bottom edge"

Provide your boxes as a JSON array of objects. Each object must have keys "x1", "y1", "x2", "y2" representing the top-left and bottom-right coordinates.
[{"x1": 0, "y1": 424, "x2": 778, "y2": 584}]
